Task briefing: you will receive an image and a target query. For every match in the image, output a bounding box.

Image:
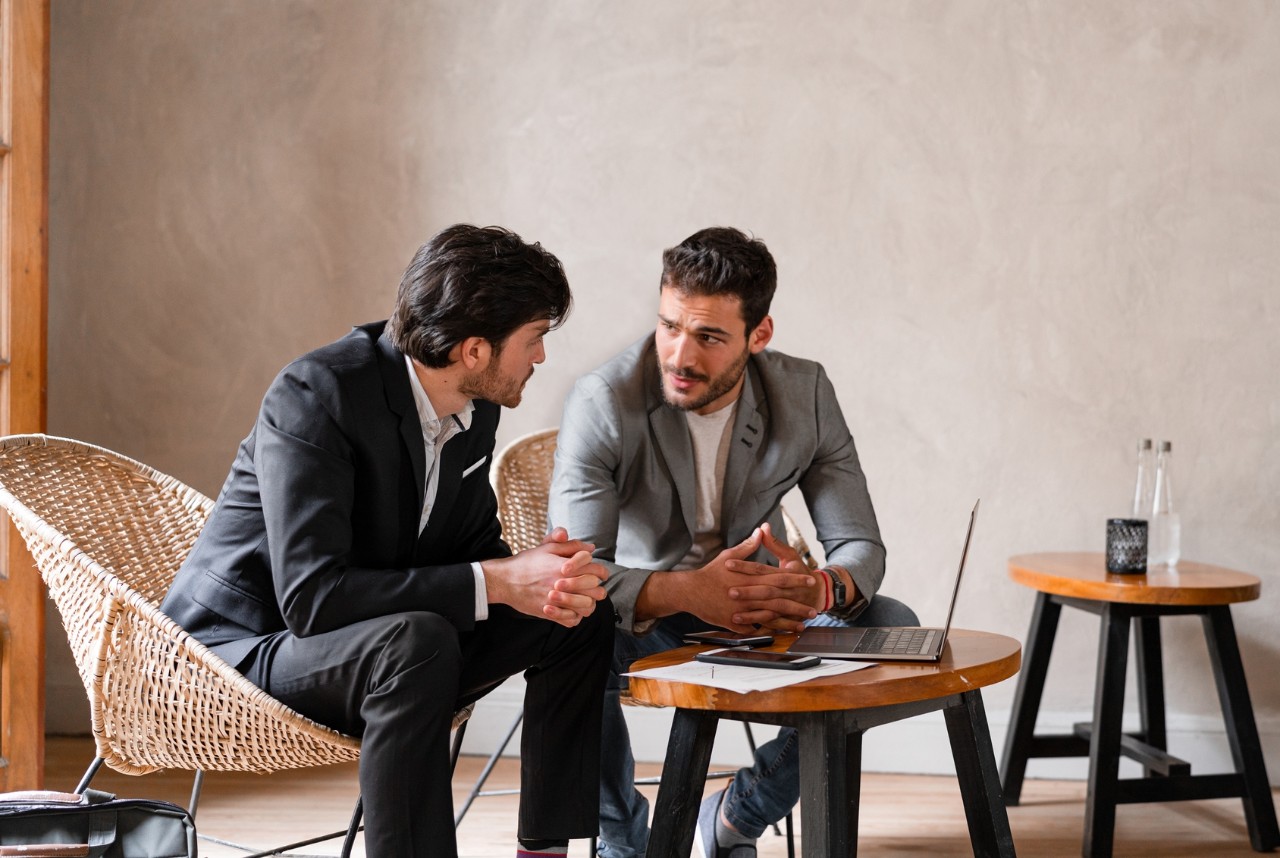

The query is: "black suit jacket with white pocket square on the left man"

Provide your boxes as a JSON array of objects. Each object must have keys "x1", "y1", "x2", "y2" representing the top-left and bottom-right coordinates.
[{"x1": 161, "y1": 323, "x2": 511, "y2": 666}]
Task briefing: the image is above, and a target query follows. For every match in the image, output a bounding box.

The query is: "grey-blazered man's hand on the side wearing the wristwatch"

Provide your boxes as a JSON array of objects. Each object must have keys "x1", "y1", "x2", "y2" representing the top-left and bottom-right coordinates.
[{"x1": 724, "y1": 522, "x2": 827, "y2": 631}]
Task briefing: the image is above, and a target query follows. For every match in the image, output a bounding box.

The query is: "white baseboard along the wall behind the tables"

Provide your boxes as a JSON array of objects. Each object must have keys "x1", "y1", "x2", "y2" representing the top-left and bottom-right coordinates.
[{"x1": 462, "y1": 683, "x2": 1280, "y2": 786}]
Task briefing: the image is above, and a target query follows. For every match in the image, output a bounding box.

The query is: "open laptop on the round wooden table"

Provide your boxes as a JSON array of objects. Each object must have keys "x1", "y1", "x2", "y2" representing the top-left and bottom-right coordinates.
[{"x1": 787, "y1": 501, "x2": 978, "y2": 661}]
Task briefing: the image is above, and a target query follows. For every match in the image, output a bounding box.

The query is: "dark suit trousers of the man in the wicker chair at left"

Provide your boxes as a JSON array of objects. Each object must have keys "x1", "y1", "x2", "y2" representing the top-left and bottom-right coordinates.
[{"x1": 239, "y1": 602, "x2": 613, "y2": 858}]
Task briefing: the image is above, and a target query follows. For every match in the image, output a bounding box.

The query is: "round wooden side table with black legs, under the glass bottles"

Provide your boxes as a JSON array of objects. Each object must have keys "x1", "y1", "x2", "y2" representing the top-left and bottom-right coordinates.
[{"x1": 1000, "y1": 553, "x2": 1280, "y2": 858}]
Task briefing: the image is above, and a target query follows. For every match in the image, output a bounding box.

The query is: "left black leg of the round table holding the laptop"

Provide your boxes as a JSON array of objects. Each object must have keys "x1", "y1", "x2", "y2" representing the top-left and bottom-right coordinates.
[{"x1": 648, "y1": 709, "x2": 719, "y2": 855}]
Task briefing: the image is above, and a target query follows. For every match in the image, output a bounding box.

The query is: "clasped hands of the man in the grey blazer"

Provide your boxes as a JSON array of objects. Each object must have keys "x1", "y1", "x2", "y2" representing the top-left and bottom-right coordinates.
[{"x1": 694, "y1": 522, "x2": 827, "y2": 633}]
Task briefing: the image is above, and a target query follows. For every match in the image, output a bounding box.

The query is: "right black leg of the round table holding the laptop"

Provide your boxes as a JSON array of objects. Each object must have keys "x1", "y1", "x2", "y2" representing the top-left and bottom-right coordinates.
[{"x1": 943, "y1": 690, "x2": 1015, "y2": 858}]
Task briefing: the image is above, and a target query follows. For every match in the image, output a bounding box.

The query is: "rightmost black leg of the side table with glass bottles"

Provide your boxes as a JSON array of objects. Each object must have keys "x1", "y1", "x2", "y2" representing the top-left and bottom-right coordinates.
[{"x1": 1202, "y1": 604, "x2": 1280, "y2": 852}]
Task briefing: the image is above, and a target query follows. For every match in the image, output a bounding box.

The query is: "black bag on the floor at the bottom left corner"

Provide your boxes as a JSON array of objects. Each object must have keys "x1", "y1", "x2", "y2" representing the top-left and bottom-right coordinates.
[{"x1": 0, "y1": 790, "x2": 196, "y2": 858}]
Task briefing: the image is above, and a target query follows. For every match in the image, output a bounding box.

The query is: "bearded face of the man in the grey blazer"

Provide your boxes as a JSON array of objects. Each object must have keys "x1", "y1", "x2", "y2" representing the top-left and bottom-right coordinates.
[{"x1": 654, "y1": 287, "x2": 773, "y2": 414}]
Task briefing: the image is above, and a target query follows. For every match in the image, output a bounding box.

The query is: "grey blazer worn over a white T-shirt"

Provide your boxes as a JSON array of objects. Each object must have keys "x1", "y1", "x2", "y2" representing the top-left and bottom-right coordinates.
[{"x1": 548, "y1": 334, "x2": 884, "y2": 630}]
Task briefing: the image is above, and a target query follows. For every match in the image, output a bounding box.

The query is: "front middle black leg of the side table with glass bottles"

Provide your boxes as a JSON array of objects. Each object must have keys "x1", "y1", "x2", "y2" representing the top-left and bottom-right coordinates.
[{"x1": 1083, "y1": 604, "x2": 1130, "y2": 858}]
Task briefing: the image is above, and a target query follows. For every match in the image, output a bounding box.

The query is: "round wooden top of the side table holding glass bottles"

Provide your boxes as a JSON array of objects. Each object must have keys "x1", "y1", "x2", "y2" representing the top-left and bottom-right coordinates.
[{"x1": 1009, "y1": 552, "x2": 1262, "y2": 606}]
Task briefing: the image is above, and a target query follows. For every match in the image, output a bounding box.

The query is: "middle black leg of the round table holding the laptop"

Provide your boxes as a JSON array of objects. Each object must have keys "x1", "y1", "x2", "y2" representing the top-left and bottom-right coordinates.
[{"x1": 798, "y1": 712, "x2": 863, "y2": 858}]
